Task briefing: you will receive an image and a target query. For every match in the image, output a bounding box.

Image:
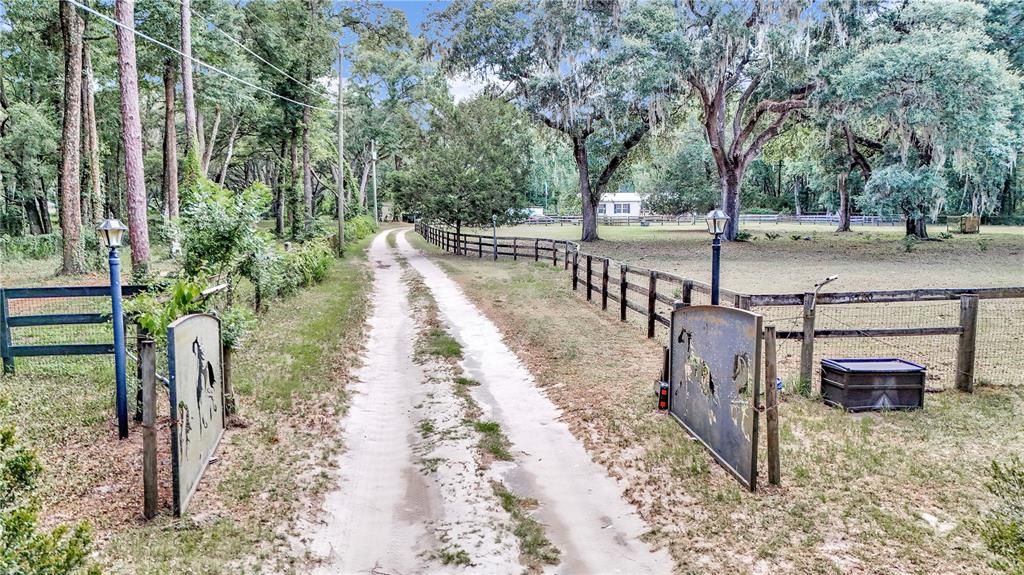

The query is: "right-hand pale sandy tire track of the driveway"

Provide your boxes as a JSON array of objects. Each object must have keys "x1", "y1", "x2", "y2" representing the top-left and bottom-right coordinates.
[{"x1": 397, "y1": 230, "x2": 672, "y2": 574}]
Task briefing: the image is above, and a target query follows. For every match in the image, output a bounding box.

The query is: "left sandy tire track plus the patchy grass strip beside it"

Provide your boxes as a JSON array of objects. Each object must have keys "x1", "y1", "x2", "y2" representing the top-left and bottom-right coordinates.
[{"x1": 310, "y1": 232, "x2": 523, "y2": 575}]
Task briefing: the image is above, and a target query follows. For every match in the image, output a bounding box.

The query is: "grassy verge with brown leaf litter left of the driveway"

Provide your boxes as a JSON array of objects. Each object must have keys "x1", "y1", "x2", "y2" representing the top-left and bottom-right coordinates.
[{"x1": 0, "y1": 238, "x2": 370, "y2": 575}]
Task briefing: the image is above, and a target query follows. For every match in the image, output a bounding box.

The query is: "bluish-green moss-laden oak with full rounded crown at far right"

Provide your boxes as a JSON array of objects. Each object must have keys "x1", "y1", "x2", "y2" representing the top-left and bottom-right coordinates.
[{"x1": 833, "y1": 0, "x2": 1021, "y2": 237}]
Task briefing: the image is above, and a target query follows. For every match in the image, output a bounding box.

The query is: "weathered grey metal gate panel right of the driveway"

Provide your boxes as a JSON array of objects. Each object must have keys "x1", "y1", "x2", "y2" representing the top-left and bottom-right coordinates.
[{"x1": 669, "y1": 306, "x2": 763, "y2": 491}]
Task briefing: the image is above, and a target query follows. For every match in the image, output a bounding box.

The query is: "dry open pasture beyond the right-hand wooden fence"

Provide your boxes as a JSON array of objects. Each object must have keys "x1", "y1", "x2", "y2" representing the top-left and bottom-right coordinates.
[{"x1": 477, "y1": 221, "x2": 1024, "y2": 294}]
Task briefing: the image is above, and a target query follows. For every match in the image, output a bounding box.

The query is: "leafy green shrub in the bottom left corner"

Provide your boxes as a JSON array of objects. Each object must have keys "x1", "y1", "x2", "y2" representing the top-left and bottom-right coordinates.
[{"x1": 0, "y1": 427, "x2": 99, "y2": 575}]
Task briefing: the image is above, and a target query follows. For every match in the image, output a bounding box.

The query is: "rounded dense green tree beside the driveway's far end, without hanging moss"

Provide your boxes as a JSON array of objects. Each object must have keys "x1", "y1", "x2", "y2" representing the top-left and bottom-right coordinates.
[{"x1": 392, "y1": 96, "x2": 529, "y2": 241}]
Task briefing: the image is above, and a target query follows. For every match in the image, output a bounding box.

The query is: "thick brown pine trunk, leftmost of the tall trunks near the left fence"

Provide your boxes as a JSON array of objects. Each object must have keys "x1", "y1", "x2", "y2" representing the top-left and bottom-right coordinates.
[{"x1": 60, "y1": 0, "x2": 85, "y2": 274}]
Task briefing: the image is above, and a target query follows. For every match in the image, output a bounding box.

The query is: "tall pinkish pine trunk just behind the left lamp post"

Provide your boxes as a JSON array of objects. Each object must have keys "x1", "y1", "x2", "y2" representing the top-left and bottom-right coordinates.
[{"x1": 114, "y1": 0, "x2": 150, "y2": 275}]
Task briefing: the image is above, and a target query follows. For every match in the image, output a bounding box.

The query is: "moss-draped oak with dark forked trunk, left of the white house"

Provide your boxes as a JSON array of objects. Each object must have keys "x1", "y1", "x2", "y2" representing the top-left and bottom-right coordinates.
[{"x1": 437, "y1": 0, "x2": 679, "y2": 241}]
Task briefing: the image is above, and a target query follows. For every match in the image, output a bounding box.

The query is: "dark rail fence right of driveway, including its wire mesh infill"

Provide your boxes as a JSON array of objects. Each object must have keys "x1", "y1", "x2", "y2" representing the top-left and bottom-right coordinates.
[{"x1": 416, "y1": 223, "x2": 1024, "y2": 389}]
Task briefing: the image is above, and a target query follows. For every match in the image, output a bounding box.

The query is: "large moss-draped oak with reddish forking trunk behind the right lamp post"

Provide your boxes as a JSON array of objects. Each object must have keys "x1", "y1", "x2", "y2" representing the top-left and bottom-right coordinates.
[{"x1": 666, "y1": 0, "x2": 840, "y2": 239}]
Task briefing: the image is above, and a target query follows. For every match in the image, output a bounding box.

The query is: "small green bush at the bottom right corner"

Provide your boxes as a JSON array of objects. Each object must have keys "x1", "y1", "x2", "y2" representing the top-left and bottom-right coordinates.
[{"x1": 981, "y1": 457, "x2": 1024, "y2": 575}]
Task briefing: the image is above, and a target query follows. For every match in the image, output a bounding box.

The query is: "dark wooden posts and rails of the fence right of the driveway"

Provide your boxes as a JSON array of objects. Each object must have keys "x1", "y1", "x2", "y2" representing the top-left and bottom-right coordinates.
[{"x1": 416, "y1": 223, "x2": 1024, "y2": 391}]
